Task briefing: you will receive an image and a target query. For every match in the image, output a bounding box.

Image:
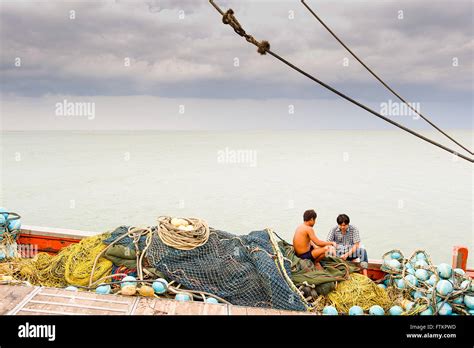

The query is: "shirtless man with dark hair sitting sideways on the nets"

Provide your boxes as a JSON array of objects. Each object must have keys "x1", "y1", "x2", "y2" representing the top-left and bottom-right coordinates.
[{"x1": 293, "y1": 210, "x2": 336, "y2": 269}]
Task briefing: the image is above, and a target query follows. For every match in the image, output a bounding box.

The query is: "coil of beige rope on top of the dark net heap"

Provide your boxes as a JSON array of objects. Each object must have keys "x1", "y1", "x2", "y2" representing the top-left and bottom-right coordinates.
[{"x1": 158, "y1": 216, "x2": 209, "y2": 250}]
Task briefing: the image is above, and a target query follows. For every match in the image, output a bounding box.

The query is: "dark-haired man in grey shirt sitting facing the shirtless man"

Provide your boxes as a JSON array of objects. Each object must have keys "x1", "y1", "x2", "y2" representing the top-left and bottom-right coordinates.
[{"x1": 327, "y1": 214, "x2": 369, "y2": 276}]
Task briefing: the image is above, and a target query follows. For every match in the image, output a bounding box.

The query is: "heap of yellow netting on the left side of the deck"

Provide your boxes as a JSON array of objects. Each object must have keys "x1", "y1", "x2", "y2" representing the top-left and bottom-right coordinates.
[{"x1": 3, "y1": 233, "x2": 112, "y2": 287}]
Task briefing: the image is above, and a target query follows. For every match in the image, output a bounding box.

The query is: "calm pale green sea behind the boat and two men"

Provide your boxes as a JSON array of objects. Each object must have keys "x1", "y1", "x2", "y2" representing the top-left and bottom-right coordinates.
[{"x1": 1, "y1": 130, "x2": 474, "y2": 266}]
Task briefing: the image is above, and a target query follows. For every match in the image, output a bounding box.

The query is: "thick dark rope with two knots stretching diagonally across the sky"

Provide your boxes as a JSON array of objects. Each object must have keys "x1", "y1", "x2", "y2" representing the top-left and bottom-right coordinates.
[{"x1": 209, "y1": 0, "x2": 474, "y2": 163}]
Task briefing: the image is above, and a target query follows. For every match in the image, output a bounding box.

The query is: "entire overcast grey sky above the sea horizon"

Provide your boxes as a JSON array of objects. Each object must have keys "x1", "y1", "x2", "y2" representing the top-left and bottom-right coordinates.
[{"x1": 0, "y1": 0, "x2": 474, "y2": 130}]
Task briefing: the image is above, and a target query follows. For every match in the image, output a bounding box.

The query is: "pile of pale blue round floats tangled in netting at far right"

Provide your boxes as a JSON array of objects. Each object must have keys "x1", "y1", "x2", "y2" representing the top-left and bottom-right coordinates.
[{"x1": 380, "y1": 249, "x2": 474, "y2": 315}]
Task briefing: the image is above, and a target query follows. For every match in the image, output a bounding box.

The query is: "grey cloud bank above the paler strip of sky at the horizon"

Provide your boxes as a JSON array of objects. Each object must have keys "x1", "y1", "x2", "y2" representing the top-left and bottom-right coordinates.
[{"x1": 0, "y1": 1, "x2": 473, "y2": 100}]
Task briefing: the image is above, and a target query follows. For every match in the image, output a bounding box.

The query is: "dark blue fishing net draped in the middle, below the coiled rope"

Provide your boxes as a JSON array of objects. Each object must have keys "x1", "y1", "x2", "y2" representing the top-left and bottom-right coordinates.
[{"x1": 118, "y1": 228, "x2": 307, "y2": 310}]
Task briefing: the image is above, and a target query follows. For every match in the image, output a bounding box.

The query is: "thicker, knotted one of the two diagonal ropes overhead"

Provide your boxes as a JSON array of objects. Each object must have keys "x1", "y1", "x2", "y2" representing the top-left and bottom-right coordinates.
[{"x1": 209, "y1": 0, "x2": 474, "y2": 163}]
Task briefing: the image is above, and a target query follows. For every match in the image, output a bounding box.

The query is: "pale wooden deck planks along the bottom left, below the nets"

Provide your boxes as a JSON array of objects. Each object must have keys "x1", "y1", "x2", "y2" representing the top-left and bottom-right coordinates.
[{"x1": 0, "y1": 285, "x2": 315, "y2": 315}]
